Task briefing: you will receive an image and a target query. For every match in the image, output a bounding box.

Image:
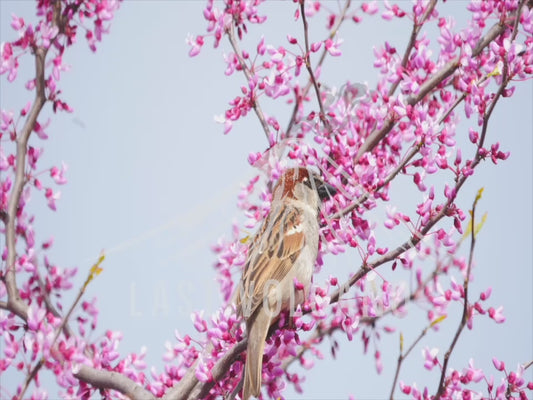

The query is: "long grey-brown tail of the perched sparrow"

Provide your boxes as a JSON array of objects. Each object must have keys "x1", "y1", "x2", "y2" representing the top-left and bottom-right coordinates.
[{"x1": 242, "y1": 310, "x2": 272, "y2": 400}]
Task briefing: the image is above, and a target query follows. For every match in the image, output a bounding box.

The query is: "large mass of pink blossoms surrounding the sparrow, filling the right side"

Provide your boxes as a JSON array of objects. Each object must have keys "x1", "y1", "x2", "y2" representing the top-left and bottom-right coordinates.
[{"x1": 181, "y1": 1, "x2": 533, "y2": 398}]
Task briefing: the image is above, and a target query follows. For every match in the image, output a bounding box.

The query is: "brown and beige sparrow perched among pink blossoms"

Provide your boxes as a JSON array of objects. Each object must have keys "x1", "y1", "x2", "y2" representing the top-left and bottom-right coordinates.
[{"x1": 236, "y1": 167, "x2": 336, "y2": 400}]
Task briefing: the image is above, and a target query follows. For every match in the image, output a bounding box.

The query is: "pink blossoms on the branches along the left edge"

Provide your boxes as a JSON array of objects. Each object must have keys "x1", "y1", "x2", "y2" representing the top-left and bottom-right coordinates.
[{"x1": 0, "y1": 0, "x2": 145, "y2": 399}]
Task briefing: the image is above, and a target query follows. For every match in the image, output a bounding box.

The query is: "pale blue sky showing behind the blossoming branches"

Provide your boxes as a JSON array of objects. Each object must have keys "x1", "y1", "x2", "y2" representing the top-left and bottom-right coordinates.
[{"x1": 0, "y1": 0, "x2": 533, "y2": 399}]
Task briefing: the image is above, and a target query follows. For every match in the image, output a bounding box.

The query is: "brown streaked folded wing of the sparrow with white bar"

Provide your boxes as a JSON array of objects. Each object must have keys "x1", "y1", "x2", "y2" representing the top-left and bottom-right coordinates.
[{"x1": 237, "y1": 204, "x2": 305, "y2": 317}]
